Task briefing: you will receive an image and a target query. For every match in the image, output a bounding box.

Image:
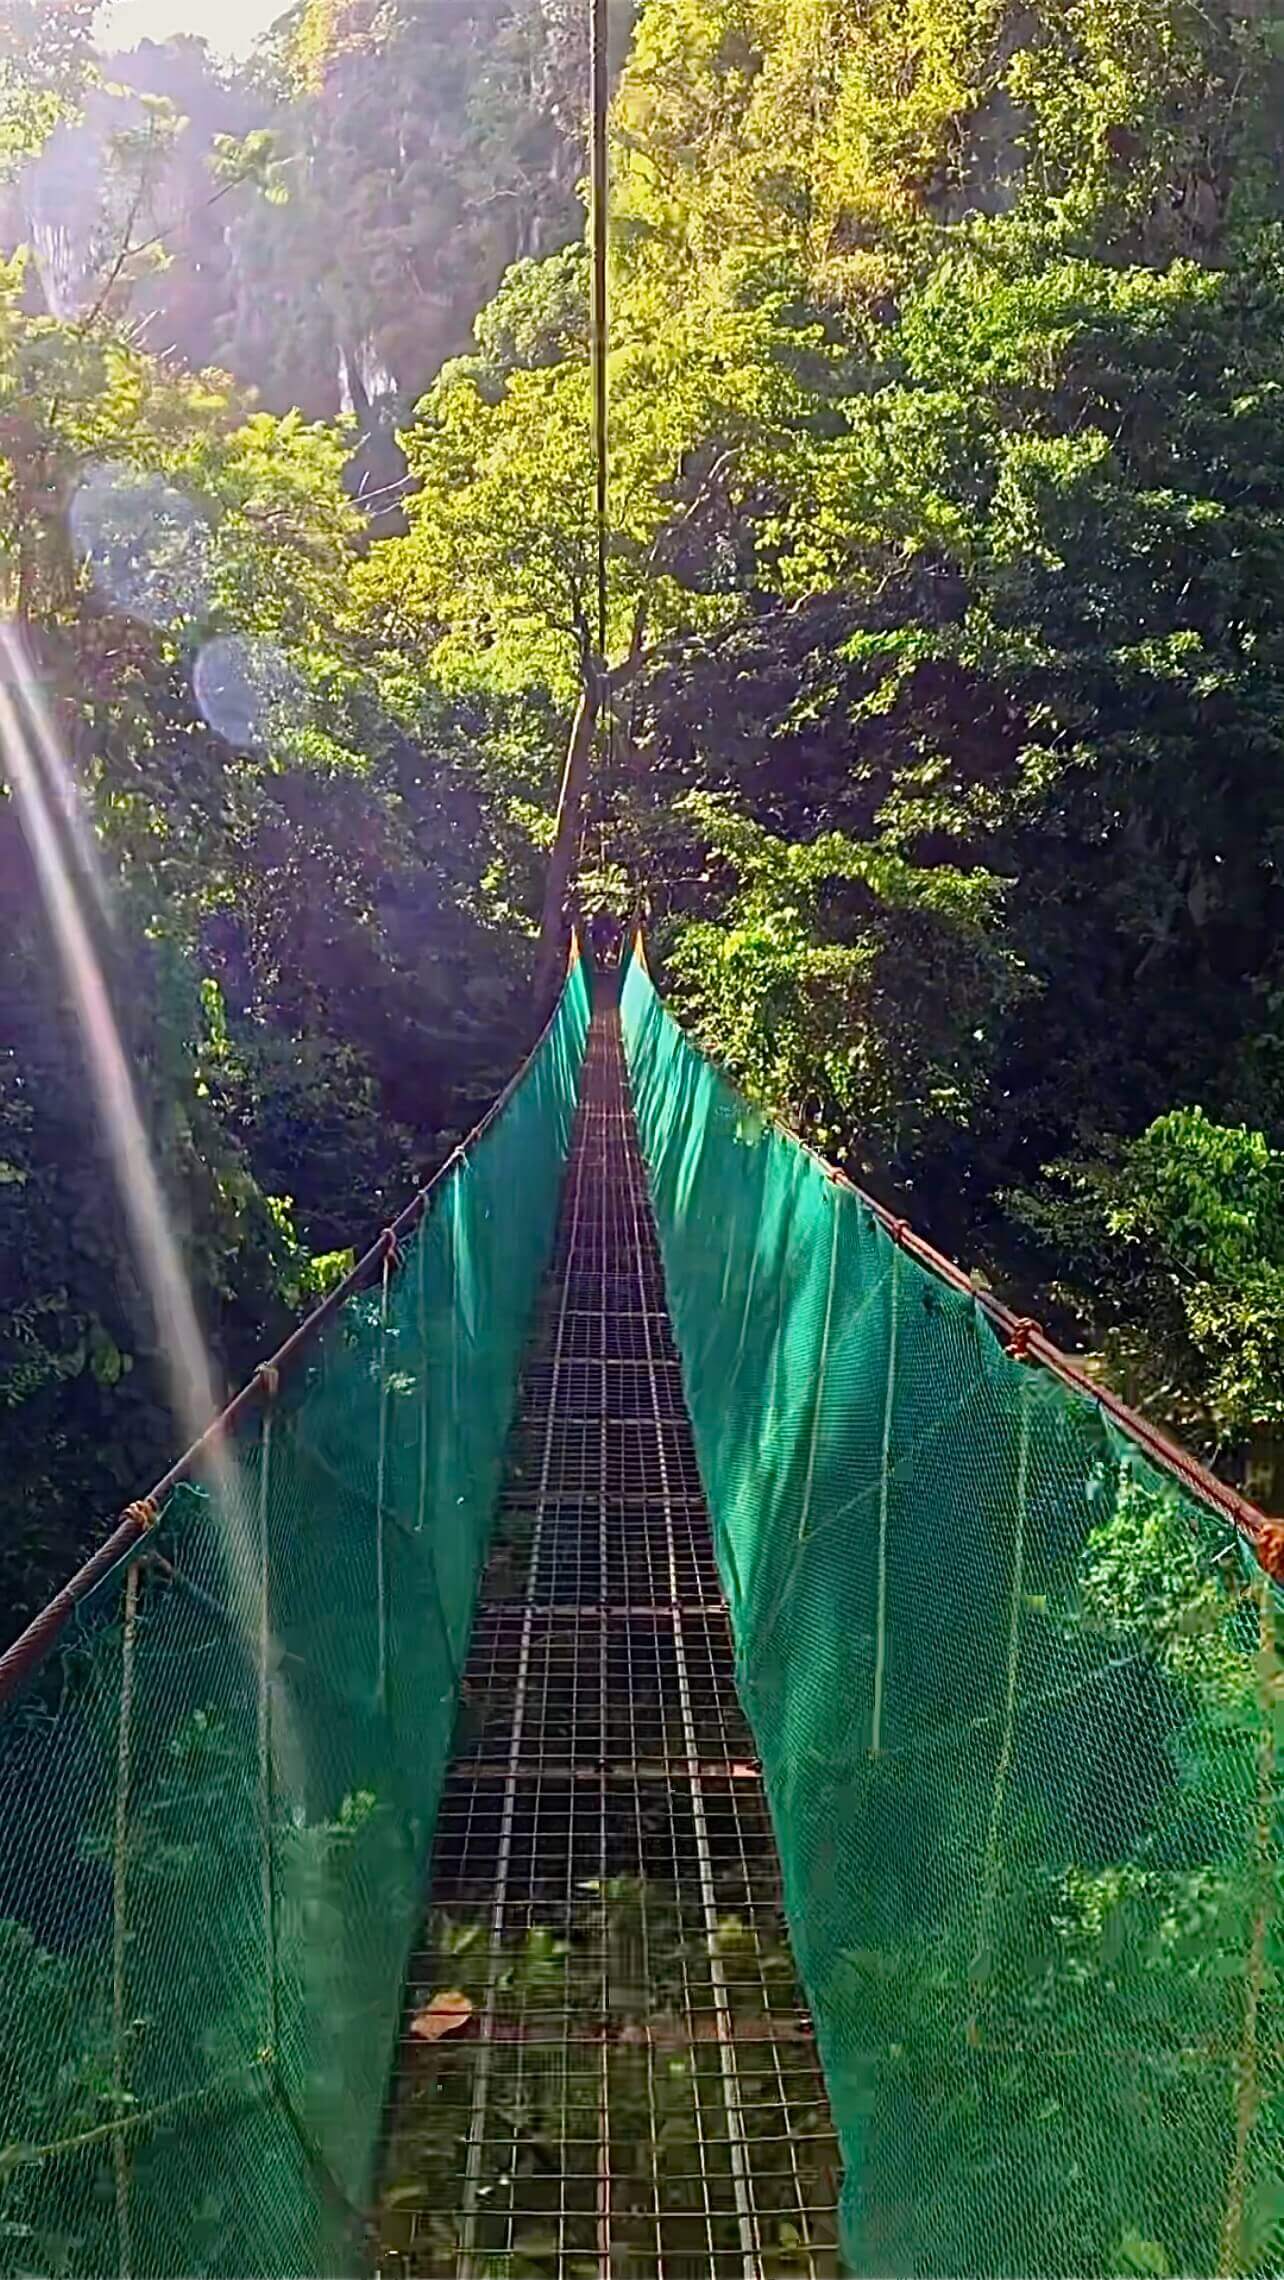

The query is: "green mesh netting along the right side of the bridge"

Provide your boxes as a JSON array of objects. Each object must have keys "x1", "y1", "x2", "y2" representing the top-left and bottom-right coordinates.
[{"x1": 623, "y1": 943, "x2": 1284, "y2": 2275}]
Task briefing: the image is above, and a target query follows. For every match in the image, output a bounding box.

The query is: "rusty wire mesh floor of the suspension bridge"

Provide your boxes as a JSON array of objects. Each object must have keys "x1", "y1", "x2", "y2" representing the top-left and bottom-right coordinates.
[{"x1": 379, "y1": 1008, "x2": 839, "y2": 2280}]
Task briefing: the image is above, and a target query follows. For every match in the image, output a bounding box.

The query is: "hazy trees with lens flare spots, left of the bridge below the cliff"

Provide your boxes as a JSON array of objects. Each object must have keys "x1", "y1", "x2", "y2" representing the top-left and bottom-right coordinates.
[{"x1": 0, "y1": 254, "x2": 533, "y2": 1623}]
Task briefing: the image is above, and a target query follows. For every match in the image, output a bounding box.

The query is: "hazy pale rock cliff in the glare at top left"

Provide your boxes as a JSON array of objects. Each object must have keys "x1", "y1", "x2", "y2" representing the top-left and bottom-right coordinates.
[{"x1": 0, "y1": 13, "x2": 602, "y2": 522}]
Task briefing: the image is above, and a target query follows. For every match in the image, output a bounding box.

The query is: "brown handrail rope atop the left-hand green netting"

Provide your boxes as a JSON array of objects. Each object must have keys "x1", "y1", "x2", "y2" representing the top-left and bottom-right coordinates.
[{"x1": 0, "y1": 928, "x2": 579, "y2": 1705}]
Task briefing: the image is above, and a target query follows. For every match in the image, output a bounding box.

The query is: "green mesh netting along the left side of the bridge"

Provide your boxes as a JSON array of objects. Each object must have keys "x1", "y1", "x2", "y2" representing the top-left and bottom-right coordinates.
[{"x1": 0, "y1": 967, "x2": 588, "y2": 2280}]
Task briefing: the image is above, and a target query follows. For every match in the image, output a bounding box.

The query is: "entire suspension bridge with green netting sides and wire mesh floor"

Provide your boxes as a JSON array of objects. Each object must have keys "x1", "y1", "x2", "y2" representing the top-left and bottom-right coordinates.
[{"x1": 0, "y1": 944, "x2": 1284, "y2": 2280}]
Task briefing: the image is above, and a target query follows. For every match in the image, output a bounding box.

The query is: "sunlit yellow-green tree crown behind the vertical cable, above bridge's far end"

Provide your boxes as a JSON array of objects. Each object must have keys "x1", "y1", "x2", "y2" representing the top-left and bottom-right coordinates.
[{"x1": 360, "y1": 276, "x2": 816, "y2": 707}]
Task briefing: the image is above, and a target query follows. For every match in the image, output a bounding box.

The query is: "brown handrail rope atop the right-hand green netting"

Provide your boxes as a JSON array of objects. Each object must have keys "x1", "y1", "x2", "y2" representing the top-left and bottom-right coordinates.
[{"x1": 634, "y1": 926, "x2": 1284, "y2": 1550}]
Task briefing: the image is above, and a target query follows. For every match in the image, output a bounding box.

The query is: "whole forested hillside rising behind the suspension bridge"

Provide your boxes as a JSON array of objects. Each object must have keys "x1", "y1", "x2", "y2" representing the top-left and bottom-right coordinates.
[{"x1": 0, "y1": 0, "x2": 1284, "y2": 1630}]
